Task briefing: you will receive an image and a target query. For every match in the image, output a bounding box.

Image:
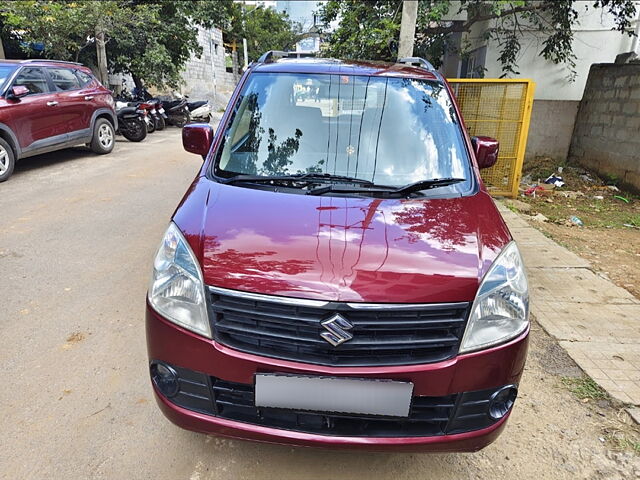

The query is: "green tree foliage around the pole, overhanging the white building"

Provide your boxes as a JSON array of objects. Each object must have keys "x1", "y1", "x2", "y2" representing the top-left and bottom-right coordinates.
[{"x1": 319, "y1": 0, "x2": 636, "y2": 76}]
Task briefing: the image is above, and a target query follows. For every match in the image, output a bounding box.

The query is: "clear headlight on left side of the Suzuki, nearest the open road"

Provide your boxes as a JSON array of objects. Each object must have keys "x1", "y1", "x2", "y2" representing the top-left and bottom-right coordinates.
[{"x1": 149, "y1": 223, "x2": 211, "y2": 338}]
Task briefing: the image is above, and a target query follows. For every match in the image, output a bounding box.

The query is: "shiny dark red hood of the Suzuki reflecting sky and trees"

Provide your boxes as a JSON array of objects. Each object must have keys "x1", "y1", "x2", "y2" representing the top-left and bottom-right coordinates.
[{"x1": 174, "y1": 177, "x2": 511, "y2": 303}]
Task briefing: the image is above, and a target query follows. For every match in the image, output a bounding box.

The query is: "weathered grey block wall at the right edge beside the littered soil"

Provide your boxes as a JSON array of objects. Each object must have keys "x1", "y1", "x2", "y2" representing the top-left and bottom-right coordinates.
[{"x1": 569, "y1": 63, "x2": 640, "y2": 190}]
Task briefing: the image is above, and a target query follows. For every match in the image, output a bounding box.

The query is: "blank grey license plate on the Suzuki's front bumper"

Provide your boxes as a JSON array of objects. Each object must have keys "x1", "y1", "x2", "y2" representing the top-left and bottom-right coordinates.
[{"x1": 255, "y1": 373, "x2": 413, "y2": 417}]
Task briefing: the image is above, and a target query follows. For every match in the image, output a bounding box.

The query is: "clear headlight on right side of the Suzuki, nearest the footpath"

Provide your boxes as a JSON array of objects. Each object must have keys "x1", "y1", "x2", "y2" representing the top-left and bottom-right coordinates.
[{"x1": 460, "y1": 242, "x2": 529, "y2": 353}]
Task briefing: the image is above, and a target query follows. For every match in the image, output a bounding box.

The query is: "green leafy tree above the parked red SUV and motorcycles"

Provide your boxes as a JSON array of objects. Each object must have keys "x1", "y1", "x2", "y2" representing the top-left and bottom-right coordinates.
[{"x1": 0, "y1": 0, "x2": 233, "y2": 87}]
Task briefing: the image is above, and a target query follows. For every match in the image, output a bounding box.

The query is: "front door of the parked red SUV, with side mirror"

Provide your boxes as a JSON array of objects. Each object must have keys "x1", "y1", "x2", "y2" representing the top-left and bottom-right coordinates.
[{"x1": 10, "y1": 67, "x2": 66, "y2": 154}]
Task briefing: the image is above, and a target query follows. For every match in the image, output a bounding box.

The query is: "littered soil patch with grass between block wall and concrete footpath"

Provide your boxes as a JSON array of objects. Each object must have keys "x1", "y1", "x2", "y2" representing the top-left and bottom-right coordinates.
[{"x1": 507, "y1": 158, "x2": 640, "y2": 297}]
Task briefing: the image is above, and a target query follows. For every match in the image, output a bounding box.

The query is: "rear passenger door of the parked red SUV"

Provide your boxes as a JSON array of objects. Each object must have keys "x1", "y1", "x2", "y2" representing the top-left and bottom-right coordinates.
[{"x1": 46, "y1": 67, "x2": 91, "y2": 140}]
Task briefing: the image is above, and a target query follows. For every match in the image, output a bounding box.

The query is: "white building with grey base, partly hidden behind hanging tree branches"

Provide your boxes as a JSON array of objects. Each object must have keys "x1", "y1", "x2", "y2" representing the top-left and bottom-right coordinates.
[{"x1": 441, "y1": 1, "x2": 640, "y2": 159}]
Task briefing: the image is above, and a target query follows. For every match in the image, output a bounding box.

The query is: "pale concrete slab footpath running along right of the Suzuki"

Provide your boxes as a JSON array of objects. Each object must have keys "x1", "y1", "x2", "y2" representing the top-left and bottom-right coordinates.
[{"x1": 496, "y1": 202, "x2": 640, "y2": 405}]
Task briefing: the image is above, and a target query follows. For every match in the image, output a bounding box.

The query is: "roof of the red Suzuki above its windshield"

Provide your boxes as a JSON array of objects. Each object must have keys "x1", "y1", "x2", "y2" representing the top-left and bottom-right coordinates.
[{"x1": 252, "y1": 57, "x2": 442, "y2": 82}]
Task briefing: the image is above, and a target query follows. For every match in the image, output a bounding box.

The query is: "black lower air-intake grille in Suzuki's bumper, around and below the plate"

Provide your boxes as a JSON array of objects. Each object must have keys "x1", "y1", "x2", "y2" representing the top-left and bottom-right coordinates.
[{"x1": 160, "y1": 366, "x2": 499, "y2": 437}]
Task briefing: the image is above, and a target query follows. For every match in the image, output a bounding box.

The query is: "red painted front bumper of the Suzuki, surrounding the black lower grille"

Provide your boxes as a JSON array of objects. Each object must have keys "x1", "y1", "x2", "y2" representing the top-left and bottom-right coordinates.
[{"x1": 146, "y1": 306, "x2": 528, "y2": 451}]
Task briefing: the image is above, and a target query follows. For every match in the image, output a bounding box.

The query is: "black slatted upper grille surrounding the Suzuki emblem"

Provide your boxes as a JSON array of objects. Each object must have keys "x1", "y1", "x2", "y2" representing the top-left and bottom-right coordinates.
[{"x1": 210, "y1": 287, "x2": 469, "y2": 366}]
